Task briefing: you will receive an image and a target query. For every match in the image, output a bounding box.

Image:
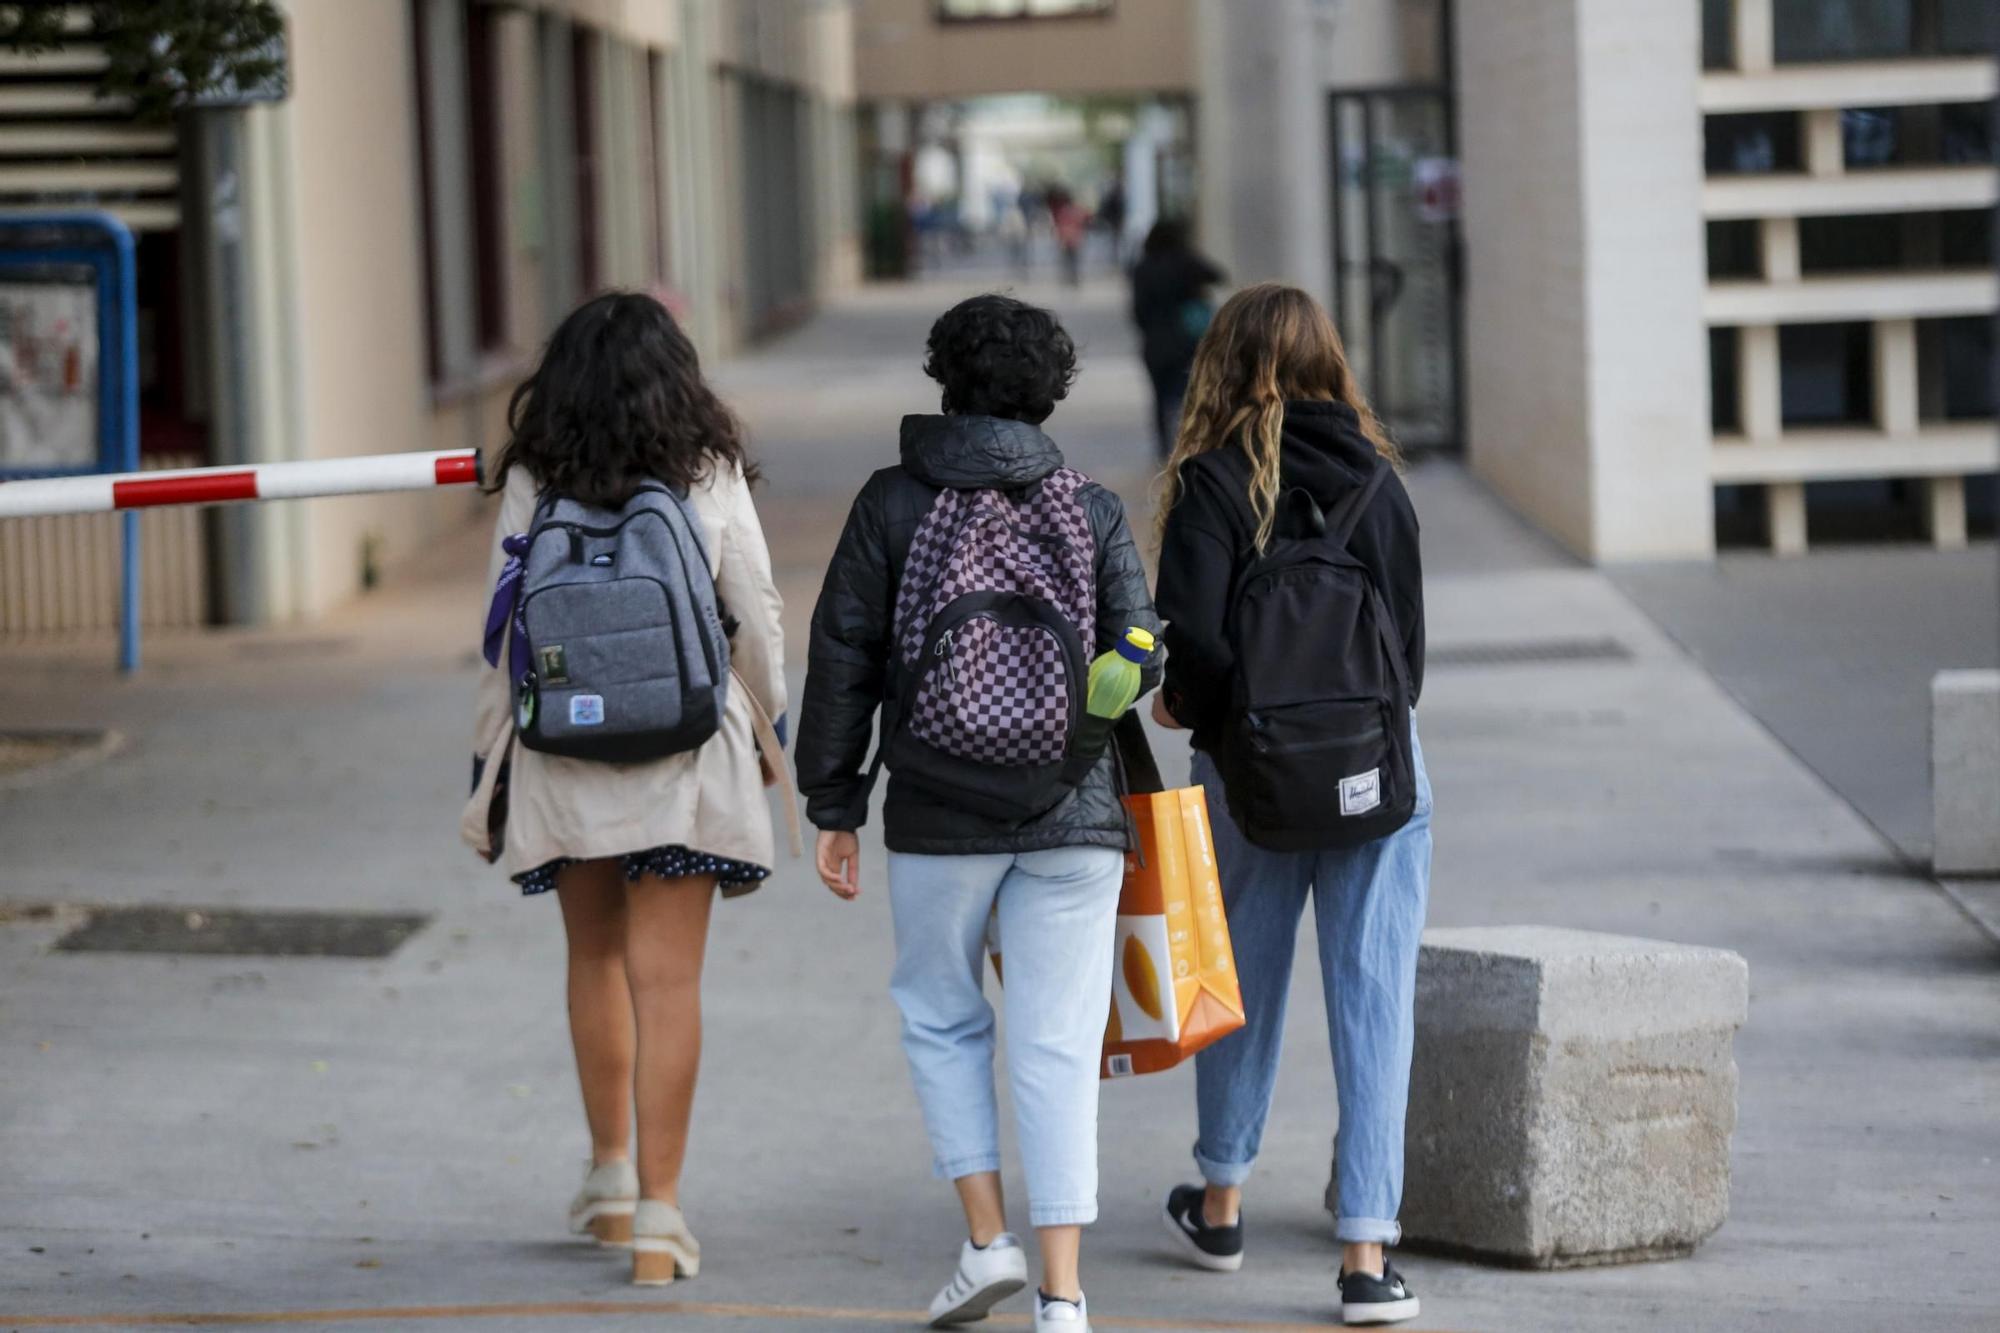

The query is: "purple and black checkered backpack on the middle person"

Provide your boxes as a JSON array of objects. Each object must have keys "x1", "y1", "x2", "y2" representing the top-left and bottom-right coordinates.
[{"x1": 886, "y1": 468, "x2": 1102, "y2": 819}]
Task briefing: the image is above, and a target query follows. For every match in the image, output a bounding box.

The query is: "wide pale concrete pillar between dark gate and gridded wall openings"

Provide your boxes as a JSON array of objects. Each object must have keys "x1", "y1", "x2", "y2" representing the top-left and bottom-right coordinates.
[{"x1": 1456, "y1": 0, "x2": 1714, "y2": 560}]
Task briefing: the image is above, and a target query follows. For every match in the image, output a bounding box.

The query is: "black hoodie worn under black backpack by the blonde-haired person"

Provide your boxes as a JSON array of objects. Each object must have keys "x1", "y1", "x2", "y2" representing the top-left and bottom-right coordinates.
[{"x1": 1158, "y1": 402, "x2": 1424, "y2": 751}]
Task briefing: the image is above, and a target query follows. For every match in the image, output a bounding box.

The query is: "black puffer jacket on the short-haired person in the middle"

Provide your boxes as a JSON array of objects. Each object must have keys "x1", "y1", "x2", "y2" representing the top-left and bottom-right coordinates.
[{"x1": 798, "y1": 416, "x2": 1160, "y2": 855}]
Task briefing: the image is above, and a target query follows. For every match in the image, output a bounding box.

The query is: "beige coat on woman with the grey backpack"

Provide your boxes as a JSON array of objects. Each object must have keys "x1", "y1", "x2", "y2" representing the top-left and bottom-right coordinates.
[{"x1": 460, "y1": 468, "x2": 796, "y2": 889}]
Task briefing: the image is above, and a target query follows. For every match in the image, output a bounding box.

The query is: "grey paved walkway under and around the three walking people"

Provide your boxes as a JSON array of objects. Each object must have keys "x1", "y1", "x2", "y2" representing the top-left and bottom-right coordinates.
[{"x1": 0, "y1": 274, "x2": 2000, "y2": 1333}]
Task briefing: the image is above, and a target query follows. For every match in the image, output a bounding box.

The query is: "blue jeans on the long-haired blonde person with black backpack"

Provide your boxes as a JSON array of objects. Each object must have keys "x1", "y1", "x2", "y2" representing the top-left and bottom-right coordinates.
[{"x1": 1194, "y1": 723, "x2": 1430, "y2": 1245}]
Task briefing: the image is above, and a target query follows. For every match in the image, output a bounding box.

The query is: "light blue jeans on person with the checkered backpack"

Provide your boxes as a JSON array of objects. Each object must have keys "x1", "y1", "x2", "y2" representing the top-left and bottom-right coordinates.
[{"x1": 888, "y1": 847, "x2": 1124, "y2": 1227}]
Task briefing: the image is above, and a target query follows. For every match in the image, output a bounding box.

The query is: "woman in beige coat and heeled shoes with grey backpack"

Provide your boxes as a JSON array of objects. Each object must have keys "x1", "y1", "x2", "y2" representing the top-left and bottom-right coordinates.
[{"x1": 464, "y1": 294, "x2": 784, "y2": 1285}]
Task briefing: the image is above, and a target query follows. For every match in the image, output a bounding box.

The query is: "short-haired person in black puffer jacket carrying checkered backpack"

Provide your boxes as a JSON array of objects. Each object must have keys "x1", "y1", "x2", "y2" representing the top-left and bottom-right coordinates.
[{"x1": 798, "y1": 296, "x2": 1158, "y2": 1333}]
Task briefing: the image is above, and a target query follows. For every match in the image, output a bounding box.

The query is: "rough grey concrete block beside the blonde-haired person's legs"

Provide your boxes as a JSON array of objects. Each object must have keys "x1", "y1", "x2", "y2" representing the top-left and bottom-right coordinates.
[{"x1": 1402, "y1": 927, "x2": 1750, "y2": 1269}]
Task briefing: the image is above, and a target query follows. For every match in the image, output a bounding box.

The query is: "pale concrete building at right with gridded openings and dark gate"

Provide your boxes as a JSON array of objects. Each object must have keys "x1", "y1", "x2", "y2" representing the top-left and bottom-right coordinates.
[{"x1": 1164, "y1": 0, "x2": 2000, "y2": 560}]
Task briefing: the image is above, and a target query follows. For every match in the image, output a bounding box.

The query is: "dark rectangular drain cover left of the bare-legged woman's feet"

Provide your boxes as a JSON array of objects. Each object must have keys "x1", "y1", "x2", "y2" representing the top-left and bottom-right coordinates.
[{"x1": 56, "y1": 907, "x2": 430, "y2": 959}]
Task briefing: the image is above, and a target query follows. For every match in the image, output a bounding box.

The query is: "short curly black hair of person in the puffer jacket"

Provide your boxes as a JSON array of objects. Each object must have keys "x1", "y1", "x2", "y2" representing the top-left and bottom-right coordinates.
[{"x1": 924, "y1": 294, "x2": 1076, "y2": 424}]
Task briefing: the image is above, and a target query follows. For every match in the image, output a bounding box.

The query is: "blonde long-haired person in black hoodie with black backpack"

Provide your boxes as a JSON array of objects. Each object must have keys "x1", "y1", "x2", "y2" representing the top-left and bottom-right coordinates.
[{"x1": 1154, "y1": 284, "x2": 1430, "y2": 1323}]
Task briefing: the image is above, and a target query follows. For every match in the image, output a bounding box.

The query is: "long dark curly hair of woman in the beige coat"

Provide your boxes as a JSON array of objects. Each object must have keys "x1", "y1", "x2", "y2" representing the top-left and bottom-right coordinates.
[{"x1": 488, "y1": 292, "x2": 758, "y2": 508}]
